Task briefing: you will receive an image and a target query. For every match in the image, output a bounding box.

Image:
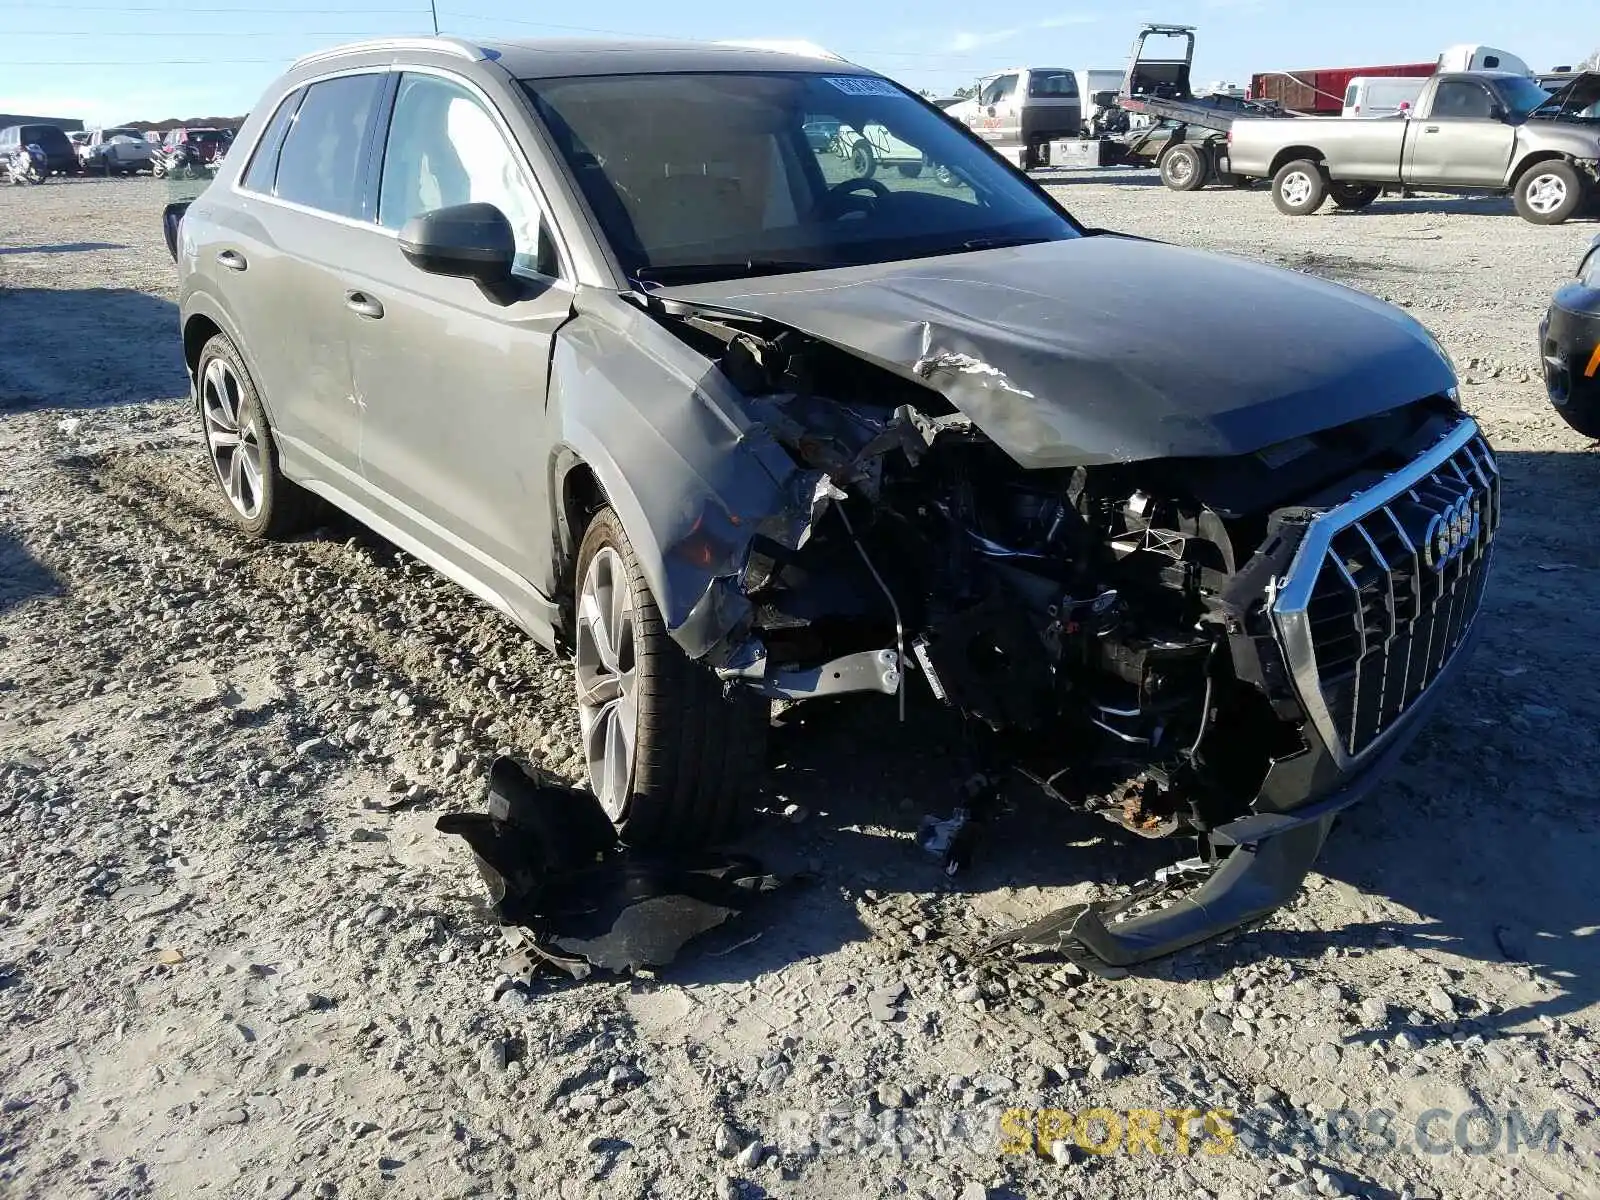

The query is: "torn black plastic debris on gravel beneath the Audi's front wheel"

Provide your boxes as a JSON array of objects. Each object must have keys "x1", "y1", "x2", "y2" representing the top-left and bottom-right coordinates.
[{"x1": 435, "y1": 757, "x2": 779, "y2": 979}]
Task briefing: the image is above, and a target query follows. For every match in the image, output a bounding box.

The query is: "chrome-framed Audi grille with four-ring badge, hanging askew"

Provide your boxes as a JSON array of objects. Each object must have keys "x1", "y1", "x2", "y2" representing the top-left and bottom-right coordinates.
[{"x1": 1272, "y1": 419, "x2": 1499, "y2": 760}]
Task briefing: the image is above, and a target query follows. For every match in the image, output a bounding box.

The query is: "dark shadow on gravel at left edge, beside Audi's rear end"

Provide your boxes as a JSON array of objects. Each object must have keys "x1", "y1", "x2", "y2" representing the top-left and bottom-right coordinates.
[{"x1": 0, "y1": 288, "x2": 189, "y2": 410}]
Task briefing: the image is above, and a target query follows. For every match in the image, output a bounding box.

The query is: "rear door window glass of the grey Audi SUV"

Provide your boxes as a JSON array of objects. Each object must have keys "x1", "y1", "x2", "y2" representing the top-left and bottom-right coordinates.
[{"x1": 272, "y1": 75, "x2": 384, "y2": 218}]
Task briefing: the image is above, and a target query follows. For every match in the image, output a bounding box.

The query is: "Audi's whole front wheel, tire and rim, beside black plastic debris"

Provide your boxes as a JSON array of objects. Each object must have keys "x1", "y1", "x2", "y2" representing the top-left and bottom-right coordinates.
[{"x1": 573, "y1": 507, "x2": 771, "y2": 850}]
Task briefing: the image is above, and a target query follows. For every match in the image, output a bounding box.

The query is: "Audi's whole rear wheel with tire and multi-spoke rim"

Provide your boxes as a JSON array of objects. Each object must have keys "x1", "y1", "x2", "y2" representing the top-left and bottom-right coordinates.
[{"x1": 195, "y1": 333, "x2": 314, "y2": 539}]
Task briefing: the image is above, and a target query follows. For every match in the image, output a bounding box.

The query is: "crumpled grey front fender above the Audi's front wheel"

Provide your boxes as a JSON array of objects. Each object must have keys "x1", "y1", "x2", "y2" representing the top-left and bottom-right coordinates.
[{"x1": 550, "y1": 290, "x2": 819, "y2": 659}]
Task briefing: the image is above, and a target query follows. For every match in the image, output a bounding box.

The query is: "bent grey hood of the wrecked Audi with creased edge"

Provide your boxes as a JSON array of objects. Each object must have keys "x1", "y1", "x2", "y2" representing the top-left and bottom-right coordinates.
[{"x1": 656, "y1": 235, "x2": 1456, "y2": 469}]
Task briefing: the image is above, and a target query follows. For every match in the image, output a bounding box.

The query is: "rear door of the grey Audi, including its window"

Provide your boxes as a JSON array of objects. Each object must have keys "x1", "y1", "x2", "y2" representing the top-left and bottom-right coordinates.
[{"x1": 214, "y1": 72, "x2": 390, "y2": 490}]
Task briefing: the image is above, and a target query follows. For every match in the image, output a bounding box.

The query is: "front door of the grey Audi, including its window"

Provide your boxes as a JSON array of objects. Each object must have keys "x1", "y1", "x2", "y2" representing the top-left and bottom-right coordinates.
[{"x1": 341, "y1": 72, "x2": 571, "y2": 614}]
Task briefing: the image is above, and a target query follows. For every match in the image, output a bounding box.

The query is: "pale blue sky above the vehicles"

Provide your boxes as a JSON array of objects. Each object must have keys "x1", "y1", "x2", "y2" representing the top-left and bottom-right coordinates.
[{"x1": 0, "y1": 0, "x2": 1580, "y2": 123}]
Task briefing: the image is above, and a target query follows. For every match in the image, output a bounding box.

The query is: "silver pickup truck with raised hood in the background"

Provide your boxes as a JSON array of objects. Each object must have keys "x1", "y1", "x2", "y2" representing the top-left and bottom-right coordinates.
[{"x1": 1227, "y1": 70, "x2": 1600, "y2": 226}]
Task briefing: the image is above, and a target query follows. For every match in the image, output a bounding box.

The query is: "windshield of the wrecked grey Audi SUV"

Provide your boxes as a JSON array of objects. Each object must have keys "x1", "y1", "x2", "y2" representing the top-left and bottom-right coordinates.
[{"x1": 523, "y1": 72, "x2": 1077, "y2": 283}]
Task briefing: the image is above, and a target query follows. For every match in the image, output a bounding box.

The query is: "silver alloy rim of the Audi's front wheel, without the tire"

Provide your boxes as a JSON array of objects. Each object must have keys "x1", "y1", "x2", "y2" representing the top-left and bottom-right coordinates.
[{"x1": 574, "y1": 546, "x2": 638, "y2": 821}]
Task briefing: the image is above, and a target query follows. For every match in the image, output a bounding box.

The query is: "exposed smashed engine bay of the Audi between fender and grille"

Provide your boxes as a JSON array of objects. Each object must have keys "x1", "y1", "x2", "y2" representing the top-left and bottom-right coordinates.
[{"x1": 661, "y1": 296, "x2": 1461, "y2": 837}]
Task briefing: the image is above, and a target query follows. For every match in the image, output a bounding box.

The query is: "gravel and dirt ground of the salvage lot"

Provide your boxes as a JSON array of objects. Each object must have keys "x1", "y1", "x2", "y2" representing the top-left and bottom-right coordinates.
[{"x1": 0, "y1": 174, "x2": 1600, "y2": 1200}]
